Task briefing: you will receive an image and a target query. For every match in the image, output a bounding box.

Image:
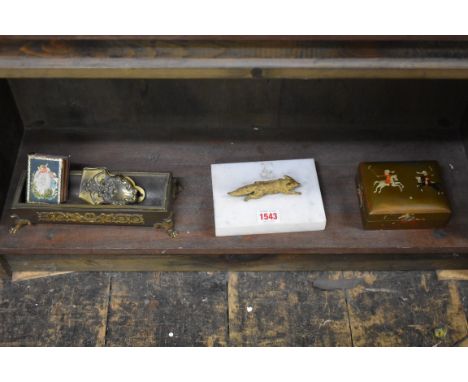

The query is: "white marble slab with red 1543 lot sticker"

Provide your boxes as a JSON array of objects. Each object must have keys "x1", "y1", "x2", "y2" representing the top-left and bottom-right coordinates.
[{"x1": 211, "y1": 159, "x2": 326, "y2": 236}]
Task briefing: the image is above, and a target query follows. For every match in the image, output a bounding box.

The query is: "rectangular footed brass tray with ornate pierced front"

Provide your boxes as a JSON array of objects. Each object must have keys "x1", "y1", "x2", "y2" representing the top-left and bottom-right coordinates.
[{"x1": 10, "y1": 171, "x2": 177, "y2": 236}]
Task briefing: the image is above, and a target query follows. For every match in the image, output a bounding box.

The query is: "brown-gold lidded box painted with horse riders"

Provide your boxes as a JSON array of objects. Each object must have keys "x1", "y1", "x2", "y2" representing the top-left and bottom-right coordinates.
[{"x1": 357, "y1": 161, "x2": 452, "y2": 229}]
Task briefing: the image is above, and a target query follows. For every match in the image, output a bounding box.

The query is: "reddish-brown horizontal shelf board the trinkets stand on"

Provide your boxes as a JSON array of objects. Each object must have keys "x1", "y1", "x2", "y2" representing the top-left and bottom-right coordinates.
[{"x1": 0, "y1": 127, "x2": 468, "y2": 258}]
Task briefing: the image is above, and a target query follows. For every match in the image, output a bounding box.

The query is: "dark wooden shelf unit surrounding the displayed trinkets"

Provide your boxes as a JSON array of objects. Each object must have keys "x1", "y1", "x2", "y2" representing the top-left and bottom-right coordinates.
[{"x1": 0, "y1": 36, "x2": 468, "y2": 271}]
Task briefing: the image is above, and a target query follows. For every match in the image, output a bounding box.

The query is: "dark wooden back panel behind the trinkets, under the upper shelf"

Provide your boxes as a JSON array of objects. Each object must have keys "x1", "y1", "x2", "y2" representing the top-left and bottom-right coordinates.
[{"x1": 8, "y1": 79, "x2": 468, "y2": 131}]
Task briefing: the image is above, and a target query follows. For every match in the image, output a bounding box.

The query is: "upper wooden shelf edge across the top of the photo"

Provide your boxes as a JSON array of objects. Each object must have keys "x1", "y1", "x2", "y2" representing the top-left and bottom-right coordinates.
[{"x1": 0, "y1": 36, "x2": 468, "y2": 78}]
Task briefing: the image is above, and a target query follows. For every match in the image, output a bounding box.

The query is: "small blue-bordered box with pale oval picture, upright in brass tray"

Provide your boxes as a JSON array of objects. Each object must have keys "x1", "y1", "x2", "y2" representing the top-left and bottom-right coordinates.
[{"x1": 26, "y1": 154, "x2": 69, "y2": 204}]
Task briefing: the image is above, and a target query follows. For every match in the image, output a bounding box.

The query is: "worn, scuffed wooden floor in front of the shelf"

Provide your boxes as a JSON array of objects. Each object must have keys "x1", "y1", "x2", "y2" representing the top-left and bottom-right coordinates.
[{"x1": 0, "y1": 271, "x2": 468, "y2": 346}]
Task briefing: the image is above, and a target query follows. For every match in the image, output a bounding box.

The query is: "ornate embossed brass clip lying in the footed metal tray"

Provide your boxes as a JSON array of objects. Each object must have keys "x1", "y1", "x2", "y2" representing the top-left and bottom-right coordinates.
[{"x1": 79, "y1": 167, "x2": 145, "y2": 205}]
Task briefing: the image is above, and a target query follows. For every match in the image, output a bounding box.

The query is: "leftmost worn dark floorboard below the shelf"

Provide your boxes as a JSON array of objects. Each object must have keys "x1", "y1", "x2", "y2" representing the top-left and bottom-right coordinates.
[{"x1": 0, "y1": 273, "x2": 109, "y2": 346}]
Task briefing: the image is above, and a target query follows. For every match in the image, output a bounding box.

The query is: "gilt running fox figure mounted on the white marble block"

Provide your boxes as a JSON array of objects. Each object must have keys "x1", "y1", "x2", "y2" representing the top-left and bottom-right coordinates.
[{"x1": 228, "y1": 175, "x2": 301, "y2": 202}]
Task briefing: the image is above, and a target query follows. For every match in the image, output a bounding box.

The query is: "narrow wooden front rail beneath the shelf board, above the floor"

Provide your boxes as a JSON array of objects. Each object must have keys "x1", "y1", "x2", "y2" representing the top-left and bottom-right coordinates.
[{"x1": 6, "y1": 253, "x2": 468, "y2": 272}]
